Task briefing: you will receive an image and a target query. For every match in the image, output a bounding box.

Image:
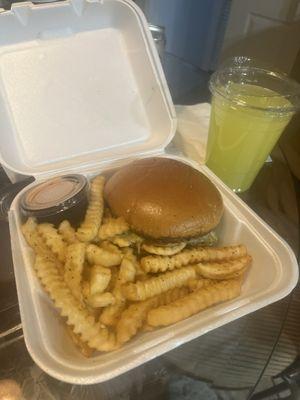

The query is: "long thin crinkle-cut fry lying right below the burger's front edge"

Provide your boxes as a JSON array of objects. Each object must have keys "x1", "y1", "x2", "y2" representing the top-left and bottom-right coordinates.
[{"x1": 141, "y1": 245, "x2": 247, "y2": 272}]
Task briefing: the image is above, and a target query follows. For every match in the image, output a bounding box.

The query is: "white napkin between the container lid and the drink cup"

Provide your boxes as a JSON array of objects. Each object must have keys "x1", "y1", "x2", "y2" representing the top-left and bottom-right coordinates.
[{"x1": 175, "y1": 103, "x2": 211, "y2": 164}]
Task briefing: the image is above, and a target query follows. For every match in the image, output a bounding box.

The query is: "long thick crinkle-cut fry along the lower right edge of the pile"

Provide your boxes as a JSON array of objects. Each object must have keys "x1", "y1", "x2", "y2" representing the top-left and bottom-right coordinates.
[{"x1": 147, "y1": 279, "x2": 241, "y2": 327}]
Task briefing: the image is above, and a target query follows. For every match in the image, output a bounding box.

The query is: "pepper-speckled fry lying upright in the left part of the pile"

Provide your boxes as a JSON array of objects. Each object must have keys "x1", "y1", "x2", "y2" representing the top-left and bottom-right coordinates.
[{"x1": 64, "y1": 242, "x2": 85, "y2": 301}]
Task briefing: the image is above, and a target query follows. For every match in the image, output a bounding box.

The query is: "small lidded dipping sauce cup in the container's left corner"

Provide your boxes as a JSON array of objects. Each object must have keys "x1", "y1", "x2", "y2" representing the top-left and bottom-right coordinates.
[{"x1": 20, "y1": 174, "x2": 89, "y2": 227}]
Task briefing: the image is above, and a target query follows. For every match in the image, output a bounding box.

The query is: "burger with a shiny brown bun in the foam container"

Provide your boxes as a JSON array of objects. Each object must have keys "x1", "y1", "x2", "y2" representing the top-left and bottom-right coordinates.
[{"x1": 104, "y1": 157, "x2": 223, "y2": 245}]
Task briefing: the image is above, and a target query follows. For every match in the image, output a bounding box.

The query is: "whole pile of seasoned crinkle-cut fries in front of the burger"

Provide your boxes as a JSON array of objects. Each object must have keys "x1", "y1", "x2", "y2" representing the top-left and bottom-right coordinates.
[{"x1": 22, "y1": 176, "x2": 251, "y2": 356}]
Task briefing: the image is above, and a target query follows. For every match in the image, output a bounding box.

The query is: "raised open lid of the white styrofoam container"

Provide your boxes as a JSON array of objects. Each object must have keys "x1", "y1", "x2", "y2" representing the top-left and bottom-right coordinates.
[{"x1": 0, "y1": 0, "x2": 176, "y2": 175}]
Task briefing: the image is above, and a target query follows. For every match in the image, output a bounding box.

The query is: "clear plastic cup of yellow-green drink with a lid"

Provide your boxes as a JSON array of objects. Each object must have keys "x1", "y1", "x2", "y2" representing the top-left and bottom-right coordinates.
[{"x1": 206, "y1": 57, "x2": 300, "y2": 192}]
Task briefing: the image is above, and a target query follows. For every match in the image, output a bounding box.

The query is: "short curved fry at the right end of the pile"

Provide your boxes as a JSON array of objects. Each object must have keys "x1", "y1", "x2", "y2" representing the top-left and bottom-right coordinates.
[{"x1": 195, "y1": 255, "x2": 252, "y2": 279}]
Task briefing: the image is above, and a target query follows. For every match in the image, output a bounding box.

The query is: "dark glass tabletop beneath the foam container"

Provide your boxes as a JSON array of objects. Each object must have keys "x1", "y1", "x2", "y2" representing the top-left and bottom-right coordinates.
[{"x1": 0, "y1": 135, "x2": 300, "y2": 400}]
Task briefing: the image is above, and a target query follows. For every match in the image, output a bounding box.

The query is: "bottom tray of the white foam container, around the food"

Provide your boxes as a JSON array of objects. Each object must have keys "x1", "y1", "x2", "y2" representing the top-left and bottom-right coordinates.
[{"x1": 10, "y1": 157, "x2": 298, "y2": 384}]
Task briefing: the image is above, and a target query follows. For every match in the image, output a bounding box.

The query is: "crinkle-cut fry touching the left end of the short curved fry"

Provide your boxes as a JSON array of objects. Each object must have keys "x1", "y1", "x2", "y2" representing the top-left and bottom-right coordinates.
[{"x1": 123, "y1": 267, "x2": 196, "y2": 301}]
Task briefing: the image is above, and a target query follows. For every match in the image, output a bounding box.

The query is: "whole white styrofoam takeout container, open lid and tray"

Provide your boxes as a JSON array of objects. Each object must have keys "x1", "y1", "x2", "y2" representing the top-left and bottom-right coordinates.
[{"x1": 0, "y1": 0, "x2": 298, "y2": 384}]
